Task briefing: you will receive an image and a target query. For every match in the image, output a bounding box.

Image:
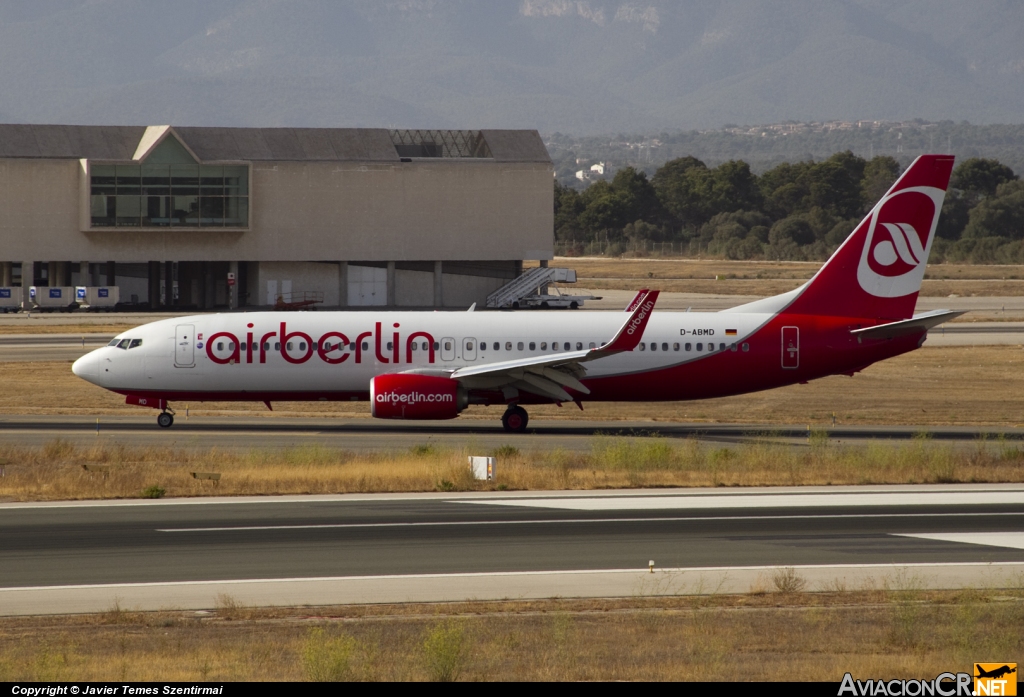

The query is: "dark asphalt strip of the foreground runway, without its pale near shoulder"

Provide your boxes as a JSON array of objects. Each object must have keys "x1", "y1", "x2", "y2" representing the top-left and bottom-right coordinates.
[{"x1": 0, "y1": 486, "x2": 1024, "y2": 587}]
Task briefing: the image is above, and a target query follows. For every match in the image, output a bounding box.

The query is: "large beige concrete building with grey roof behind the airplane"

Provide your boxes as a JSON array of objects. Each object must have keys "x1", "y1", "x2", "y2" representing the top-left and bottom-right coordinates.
[{"x1": 0, "y1": 125, "x2": 554, "y2": 310}]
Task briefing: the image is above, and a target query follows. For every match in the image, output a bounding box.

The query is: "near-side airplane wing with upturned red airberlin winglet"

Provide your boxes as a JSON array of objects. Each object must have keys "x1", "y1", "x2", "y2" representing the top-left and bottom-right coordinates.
[{"x1": 451, "y1": 291, "x2": 659, "y2": 401}]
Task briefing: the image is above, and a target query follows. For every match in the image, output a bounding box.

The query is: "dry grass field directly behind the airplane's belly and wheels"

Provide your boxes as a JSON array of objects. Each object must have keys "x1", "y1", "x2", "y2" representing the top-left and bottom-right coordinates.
[{"x1": 0, "y1": 346, "x2": 1024, "y2": 428}]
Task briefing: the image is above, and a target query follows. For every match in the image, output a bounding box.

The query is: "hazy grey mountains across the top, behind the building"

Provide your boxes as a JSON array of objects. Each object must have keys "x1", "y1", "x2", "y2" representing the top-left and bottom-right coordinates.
[{"x1": 0, "y1": 0, "x2": 1024, "y2": 135}]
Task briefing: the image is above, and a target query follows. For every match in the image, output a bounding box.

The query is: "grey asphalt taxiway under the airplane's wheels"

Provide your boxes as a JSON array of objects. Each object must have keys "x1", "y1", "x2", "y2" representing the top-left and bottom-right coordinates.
[{"x1": 0, "y1": 411, "x2": 1024, "y2": 454}]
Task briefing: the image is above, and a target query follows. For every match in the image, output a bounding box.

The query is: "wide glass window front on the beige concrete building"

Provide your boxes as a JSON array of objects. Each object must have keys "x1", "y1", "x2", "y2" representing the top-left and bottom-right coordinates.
[{"x1": 90, "y1": 164, "x2": 249, "y2": 227}]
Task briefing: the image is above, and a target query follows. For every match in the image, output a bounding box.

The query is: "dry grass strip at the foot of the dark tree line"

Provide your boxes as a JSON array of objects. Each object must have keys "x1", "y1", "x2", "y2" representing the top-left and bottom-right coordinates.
[{"x1": 551, "y1": 257, "x2": 1024, "y2": 297}]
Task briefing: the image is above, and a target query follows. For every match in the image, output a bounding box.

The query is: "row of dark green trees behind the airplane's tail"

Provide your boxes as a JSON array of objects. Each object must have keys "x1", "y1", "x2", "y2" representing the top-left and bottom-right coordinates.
[{"x1": 554, "y1": 150, "x2": 1024, "y2": 264}]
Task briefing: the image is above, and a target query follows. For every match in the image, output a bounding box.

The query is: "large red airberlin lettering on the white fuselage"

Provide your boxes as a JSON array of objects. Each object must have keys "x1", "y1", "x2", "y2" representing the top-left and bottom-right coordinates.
[{"x1": 200, "y1": 322, "x2": 435, "y2": 365}]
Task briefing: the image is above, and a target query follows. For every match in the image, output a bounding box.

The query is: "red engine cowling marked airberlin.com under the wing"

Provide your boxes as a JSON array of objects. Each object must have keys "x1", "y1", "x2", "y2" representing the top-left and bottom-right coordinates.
[{"x1": 370, "y1": 374, "x2": 466, "y2": 419}]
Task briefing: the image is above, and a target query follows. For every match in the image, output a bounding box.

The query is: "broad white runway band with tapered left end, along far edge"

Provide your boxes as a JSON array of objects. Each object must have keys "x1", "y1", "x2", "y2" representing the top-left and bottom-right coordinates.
[{"x1": 459, "y1": 491, "x2": 1024, "y2": 511}]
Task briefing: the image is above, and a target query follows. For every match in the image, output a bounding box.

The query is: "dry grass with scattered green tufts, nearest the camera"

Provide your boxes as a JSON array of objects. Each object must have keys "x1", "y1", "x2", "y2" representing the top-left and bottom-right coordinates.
[{"x1": 0, "y1": 585, "x2": 1024, "y2": 683}]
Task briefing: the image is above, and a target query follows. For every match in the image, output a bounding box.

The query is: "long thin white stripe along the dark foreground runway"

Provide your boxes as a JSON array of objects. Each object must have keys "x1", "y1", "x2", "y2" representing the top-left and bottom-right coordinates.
[{"x1": 157, "y1": 511, "x2": 1024, "y2": 532}]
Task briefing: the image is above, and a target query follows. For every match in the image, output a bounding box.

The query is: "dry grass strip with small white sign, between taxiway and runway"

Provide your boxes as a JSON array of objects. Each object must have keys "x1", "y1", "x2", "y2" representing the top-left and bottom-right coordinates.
[{"x1": 0, "y1": 431, "x2": 1024, "y2": 500}]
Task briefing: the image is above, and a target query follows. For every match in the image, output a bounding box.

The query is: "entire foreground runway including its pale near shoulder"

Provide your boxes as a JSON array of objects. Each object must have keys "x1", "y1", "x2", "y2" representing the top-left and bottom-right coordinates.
[{"x1": 0, "y1": 485, "x2": 1024, "y2": 615}]
